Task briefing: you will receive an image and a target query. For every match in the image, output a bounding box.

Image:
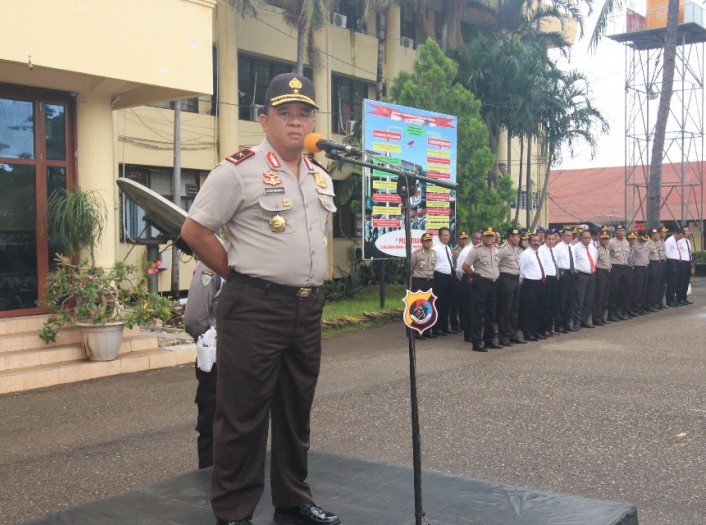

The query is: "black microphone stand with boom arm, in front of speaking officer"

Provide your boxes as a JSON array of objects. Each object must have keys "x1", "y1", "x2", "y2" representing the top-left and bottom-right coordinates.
[{"x1": 326, "y1": 150, "x2": 458, "y2": 525}]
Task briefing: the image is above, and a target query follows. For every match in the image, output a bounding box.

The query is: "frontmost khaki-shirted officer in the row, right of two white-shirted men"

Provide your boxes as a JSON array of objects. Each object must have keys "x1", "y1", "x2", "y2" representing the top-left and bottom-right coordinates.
[{"x1": 462, "y1": 226, "x2": 502, "y2": 352}]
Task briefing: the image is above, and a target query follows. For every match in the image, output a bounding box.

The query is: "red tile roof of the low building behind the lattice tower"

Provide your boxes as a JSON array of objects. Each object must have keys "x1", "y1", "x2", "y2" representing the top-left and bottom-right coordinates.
[{"x1": 547, "y1": 162, "x2": 706, "y2": 224}]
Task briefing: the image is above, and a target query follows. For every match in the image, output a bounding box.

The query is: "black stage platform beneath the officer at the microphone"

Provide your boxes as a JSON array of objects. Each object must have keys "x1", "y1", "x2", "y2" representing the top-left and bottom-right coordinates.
[{"x1": 24, "y1": 452, "x2": 637, "y2": 525}]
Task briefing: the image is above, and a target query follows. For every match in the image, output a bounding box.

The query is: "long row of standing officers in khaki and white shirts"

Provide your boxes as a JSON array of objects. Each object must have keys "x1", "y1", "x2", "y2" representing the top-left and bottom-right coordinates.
[{"x1": 411, "y1": 224, "x2": 693, "y2": 352}]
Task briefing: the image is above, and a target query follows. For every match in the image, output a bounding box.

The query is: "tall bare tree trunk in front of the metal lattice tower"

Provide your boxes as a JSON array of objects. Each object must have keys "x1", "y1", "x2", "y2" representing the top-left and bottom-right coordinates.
[{"x1": 645, "y1": 0, "x2": 684, "y2": 229}]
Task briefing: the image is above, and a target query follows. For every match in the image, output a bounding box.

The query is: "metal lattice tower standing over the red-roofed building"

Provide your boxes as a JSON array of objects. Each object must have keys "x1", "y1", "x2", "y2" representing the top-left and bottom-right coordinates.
[{"x1": 610, "y1": 2, "x2": 706, "y2": 231}]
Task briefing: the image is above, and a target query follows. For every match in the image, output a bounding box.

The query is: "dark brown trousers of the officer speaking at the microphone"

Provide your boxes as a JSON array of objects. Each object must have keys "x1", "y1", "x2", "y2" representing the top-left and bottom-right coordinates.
[{"x1": 211, "y1": 280, "x2": 324, "y2": 520}]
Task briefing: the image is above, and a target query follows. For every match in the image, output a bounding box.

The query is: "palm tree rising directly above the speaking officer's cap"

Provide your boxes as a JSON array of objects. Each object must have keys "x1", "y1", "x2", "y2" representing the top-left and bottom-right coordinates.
[{"x1": 268, "y1": 0, "x2": 331, "y2": 75}]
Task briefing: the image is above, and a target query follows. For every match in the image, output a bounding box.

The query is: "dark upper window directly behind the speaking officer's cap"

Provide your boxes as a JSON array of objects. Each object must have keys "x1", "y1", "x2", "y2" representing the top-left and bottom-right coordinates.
[{"x1": 238, "y1": 55, "x2": 311, "y2": 121}]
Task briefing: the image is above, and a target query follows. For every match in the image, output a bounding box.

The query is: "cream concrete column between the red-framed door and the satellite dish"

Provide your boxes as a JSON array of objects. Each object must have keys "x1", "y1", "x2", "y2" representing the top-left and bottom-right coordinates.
[{"x1": 76, "y1": 95, "x2": 115, "y2": 267}]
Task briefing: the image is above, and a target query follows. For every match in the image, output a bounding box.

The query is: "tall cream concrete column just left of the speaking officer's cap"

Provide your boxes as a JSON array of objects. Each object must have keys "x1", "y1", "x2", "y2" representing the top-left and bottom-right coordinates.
[{"x1": 215, "y1": 0, "x2": 240, "y2": 157}]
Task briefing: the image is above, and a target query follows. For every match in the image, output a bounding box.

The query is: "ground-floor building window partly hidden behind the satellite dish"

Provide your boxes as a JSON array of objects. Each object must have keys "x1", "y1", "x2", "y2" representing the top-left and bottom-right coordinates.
[{"x1": 120, "y1": 164, "x2": 207, "y2": 242}]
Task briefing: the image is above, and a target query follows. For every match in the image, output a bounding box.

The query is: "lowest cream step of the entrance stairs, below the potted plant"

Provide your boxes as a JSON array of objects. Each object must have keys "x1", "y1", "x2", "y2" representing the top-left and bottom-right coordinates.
[{"x1": 0, "y1": 344, "x2": 196, "y2": 394}]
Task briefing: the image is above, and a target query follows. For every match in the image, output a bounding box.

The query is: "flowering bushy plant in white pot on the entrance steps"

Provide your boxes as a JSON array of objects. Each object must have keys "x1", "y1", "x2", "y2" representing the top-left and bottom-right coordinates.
[{"x1": 38, "y1": 255, "x2": 171, "y2": 361}]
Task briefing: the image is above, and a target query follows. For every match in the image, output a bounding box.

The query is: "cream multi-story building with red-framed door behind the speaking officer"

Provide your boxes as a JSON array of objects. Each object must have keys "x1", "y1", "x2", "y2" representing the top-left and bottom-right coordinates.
[{"x1": 0, "y1": 0, "x2": 564, "y2": 317}]
